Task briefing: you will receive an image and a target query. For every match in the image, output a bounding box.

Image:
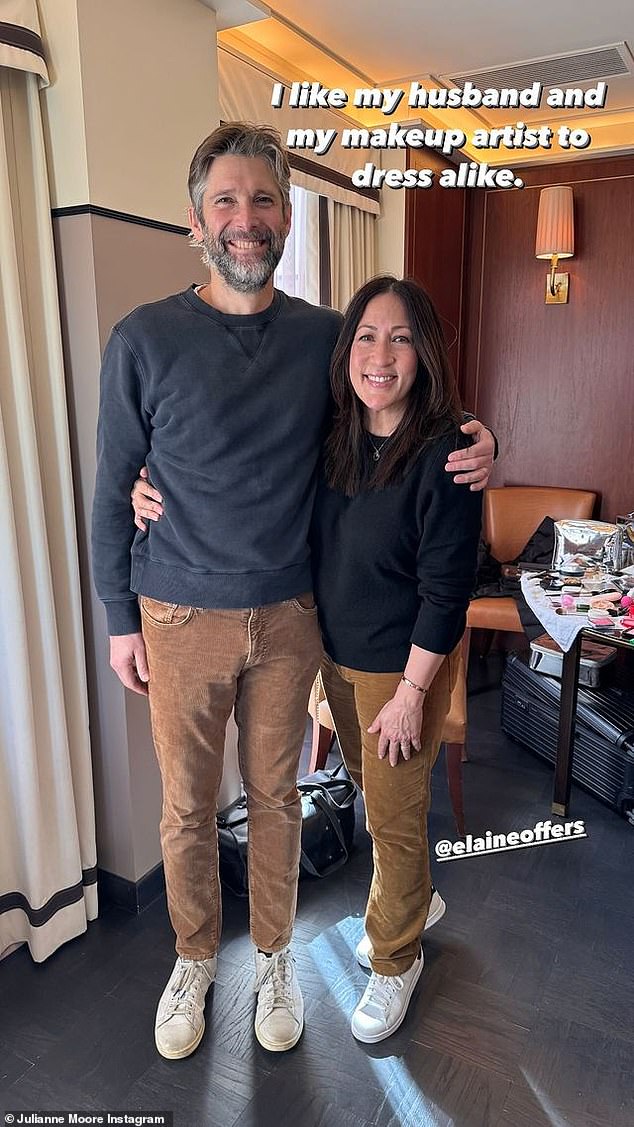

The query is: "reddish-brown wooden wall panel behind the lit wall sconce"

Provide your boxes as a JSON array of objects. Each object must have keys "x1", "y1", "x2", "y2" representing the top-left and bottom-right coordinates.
[{"x1": 462, "y1": 158, "x2": 634, "y2": 518}]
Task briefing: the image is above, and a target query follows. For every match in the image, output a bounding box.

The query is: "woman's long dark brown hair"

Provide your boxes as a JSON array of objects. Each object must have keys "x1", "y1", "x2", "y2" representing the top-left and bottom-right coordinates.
[{"x1": 325, "y1": 274, "x2": 462, "y2": 497}]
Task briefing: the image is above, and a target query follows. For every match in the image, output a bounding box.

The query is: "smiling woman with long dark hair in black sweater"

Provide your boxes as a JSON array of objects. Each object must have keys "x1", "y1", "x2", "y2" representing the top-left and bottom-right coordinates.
[{"x1": 311, "y1": 276, "x2": 481, "y2": 1044}]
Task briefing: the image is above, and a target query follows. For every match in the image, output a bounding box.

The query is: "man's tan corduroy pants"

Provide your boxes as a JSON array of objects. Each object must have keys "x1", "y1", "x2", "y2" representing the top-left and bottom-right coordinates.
[{"x1": 141, "y1": 595, "x2": 321, "y2": 959}]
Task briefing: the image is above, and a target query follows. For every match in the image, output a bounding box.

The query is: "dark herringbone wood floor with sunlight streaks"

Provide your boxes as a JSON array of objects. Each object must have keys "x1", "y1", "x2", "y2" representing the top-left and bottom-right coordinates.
[{"x1": 0, "y1": 657, "x2": 634, "y2": 1127}]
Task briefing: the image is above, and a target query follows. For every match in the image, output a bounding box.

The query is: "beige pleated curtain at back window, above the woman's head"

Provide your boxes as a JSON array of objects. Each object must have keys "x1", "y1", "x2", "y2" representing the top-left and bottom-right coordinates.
[{"x1": 328, "y1": 199, "x2": 376, "y2": 310}]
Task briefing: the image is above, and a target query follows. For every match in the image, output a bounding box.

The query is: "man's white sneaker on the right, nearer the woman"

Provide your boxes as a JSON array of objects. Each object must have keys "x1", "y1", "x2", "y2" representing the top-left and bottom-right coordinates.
[{"x1": 253, "y1": 947, "x2": 304, "y2": 1053}]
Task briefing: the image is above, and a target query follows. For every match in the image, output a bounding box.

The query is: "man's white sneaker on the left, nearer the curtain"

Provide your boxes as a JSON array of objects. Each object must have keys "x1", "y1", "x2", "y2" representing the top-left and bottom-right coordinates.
[{"x1": 154, "y1": 955, "x2": 217, "y2": 1061}]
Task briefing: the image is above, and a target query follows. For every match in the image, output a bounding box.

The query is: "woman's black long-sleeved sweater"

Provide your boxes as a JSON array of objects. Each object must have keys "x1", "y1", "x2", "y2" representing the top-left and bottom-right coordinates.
[{"x1": 311, "y1": 431, "x2": 482, "y2": 673}]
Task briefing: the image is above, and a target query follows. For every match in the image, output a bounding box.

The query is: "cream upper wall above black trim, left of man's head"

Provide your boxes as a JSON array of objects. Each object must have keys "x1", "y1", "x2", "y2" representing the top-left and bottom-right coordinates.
[{"x1": 38, "y1": 0, "x2": 218, "y2": 224}]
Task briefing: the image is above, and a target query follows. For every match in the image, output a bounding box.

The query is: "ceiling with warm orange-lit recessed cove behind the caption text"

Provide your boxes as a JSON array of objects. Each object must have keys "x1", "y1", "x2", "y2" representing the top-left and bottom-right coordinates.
[{"x1": 218, "y1": 0, "x2": 634, "y2": 167}]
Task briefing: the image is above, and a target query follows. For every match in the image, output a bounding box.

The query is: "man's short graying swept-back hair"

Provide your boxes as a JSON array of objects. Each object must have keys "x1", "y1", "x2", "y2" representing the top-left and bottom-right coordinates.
[{"x1": 187, "y1": 122, "x2": 291, "y2": 224}]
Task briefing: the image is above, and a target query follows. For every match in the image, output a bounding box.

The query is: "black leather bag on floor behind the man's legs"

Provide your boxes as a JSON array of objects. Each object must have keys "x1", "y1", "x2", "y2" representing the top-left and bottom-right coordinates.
[{"x1": 216, "y1": 763, "x2": 357, "y2": 896}]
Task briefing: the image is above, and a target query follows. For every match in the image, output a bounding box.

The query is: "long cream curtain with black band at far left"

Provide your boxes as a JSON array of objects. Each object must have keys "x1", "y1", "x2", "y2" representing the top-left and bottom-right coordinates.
[{"x1": 0, "y1": 24, "x2": 97, "y2": 961}]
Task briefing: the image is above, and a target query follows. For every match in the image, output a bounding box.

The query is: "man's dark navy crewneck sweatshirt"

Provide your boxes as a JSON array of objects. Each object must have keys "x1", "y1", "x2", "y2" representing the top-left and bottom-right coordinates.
[{"x1": 92, "y1": 289, "x2": 341, "y2": 635}]
